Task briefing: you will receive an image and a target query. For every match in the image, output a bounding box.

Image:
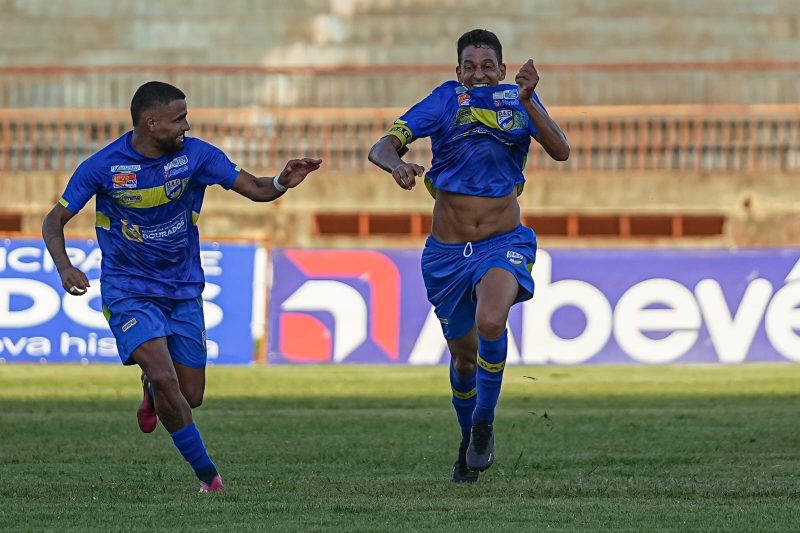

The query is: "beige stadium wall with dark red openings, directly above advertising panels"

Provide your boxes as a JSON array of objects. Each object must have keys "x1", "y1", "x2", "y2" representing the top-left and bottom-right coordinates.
[{"x1": 0, "y1": 169, "x2": 800, "y2": 248}]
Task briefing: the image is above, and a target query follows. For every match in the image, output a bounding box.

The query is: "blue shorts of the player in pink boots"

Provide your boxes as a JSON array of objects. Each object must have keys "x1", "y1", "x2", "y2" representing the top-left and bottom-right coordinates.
[{"x1": 100, "y1": 285, "x2": 208, "y2": 368}]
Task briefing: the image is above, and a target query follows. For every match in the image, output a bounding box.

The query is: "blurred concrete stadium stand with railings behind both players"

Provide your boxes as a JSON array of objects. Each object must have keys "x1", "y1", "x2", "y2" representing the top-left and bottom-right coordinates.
[{"x1": 0, "y1": 0, "x2": 800, "y2": 246}]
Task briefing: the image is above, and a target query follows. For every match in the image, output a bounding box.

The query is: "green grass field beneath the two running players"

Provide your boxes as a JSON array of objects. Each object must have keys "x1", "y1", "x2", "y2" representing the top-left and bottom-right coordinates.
[{"x1": 0, "y1": 364, "x2": 800, "y2": 532}]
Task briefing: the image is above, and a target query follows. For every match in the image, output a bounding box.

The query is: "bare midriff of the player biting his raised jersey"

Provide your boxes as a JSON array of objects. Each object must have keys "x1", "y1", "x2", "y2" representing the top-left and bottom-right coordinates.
[{"x1": 432, "y1": 190, "x2": 520, "y2": 244}]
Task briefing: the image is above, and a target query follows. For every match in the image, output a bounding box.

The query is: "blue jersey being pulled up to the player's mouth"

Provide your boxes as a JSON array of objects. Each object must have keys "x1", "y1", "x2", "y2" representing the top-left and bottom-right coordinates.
[{"x1": 389, "y1": 81, "x2": 544, "y2": 197}]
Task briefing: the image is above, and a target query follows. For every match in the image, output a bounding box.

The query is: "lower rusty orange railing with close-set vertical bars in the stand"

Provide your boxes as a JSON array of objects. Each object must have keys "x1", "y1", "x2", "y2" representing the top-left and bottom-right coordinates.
[{"x1": 0, "y1": 105, "x2": 800, "y2": 172}]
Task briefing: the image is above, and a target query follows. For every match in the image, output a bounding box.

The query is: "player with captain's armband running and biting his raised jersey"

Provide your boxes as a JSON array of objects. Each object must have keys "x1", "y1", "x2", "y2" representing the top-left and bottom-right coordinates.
[{"x1": 369, "y1": 30, "x2": 569, "y2": 483}]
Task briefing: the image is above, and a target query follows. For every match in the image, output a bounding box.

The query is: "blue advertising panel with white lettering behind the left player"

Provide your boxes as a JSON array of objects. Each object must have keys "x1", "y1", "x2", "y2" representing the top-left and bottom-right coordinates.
[{"x1": 0, "y1": 239, "x2": 263, "y2": 364}]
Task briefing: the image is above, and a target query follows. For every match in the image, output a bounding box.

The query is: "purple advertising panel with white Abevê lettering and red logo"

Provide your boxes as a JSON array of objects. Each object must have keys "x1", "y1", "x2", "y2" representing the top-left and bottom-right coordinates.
[{"x1": 267, "y1": 248, "x2": 800, "y2": 365}]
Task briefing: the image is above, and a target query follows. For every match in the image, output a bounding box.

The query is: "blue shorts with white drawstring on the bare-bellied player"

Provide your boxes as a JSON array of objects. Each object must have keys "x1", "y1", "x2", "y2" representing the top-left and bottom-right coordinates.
[{"x1": 422, "y1": 225, "x2": 536, "y2": 340}]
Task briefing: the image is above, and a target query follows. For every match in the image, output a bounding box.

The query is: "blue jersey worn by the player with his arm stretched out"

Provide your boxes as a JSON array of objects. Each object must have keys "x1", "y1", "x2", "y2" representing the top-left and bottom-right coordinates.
[{"x1": 60, "y1": 132, "x2": 241, "y2": 299}]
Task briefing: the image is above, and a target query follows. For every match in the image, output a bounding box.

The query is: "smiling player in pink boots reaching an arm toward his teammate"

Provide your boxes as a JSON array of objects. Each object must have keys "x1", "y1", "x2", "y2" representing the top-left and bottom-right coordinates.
[{"x1": 42, "y1": 81, "x2": 322, "y2": 492}]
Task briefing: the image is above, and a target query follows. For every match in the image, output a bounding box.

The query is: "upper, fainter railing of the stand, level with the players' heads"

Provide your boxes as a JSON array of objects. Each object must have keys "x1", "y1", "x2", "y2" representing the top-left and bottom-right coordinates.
[{"x1": 0, "y1": 61, "x2": 800, "y2": 109}]
